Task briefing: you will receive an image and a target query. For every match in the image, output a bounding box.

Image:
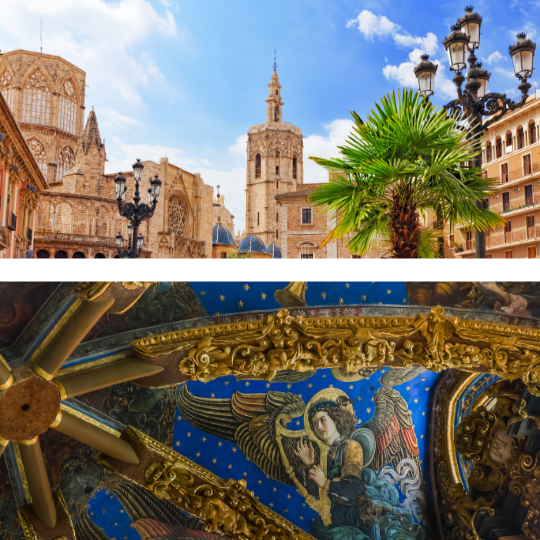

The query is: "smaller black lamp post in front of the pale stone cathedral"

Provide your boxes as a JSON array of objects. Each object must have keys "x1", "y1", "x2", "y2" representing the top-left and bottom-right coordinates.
[{"x1": 114, "y1": 159, "x2": 161, "y2": 259}]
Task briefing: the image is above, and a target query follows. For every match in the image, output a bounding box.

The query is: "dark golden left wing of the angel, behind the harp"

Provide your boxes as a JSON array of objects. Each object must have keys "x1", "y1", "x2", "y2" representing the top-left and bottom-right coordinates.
[{"x1": 178, "y1": 385, "x2": 305, "y2": 485}]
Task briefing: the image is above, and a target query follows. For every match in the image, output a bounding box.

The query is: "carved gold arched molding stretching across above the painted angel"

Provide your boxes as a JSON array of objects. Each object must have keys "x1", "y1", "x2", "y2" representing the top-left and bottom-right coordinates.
[{"x1": 132, "y1": 306, "x2": 540, "y2": 395}]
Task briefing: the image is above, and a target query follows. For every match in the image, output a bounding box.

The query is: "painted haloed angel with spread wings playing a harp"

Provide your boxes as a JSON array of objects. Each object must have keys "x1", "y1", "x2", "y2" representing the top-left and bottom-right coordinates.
[{"x1": 178, "y1": 386, "x2": 424, "y2": 540}]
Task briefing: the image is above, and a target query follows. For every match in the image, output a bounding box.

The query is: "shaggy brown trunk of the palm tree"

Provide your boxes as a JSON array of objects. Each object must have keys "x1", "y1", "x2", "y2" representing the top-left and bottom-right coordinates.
[{"x1": 390, "y1": 188, "x2": 421, "y2": 259}]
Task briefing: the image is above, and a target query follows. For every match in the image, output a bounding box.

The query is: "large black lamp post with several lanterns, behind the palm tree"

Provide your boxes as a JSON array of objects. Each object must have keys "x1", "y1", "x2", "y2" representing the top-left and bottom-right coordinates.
[{"x1": 414, "y1": 7, "x2": 536, "y2": 259}]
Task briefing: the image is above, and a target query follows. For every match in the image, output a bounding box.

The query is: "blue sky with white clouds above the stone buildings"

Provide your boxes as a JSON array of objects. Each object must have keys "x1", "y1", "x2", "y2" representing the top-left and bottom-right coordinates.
[{"x1": 0, "y1": 0, "x2": 540, "y2": 229}]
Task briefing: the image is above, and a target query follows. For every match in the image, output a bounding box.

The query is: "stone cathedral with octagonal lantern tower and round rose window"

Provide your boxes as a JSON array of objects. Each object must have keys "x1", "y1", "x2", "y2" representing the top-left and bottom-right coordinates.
[{"x1": 0, "y1": 51, "x2": 213, "y2": 258}]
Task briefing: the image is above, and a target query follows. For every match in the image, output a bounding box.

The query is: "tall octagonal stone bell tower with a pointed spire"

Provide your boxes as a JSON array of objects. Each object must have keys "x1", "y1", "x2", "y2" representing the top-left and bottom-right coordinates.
[{"x1": 246, "y1": 61, "x2": 304, "y2": 245}]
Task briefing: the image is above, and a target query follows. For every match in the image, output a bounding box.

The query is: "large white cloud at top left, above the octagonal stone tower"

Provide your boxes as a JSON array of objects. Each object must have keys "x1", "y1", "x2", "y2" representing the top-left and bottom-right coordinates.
[{"x1": 0, "y1": 0, "x2": 177, "y2": 105}]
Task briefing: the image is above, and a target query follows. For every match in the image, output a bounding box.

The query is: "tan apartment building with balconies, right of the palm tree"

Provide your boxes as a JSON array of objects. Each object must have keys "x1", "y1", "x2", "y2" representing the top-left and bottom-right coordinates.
[{"x1": 451, "y1": 90, "x2": 540, "y2": 259}]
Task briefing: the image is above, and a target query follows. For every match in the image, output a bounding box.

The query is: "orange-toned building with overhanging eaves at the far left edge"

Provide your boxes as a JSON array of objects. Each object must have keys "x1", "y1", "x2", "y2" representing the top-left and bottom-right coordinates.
[{"x1": 0, "y1": 88, "x2": 48, "y2": 259}]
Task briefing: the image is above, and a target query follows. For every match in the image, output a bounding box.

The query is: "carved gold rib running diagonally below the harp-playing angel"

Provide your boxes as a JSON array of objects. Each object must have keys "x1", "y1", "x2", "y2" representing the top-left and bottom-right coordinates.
[{"x1": 99, "y1": 426, "x2": 313, "y2": 540}]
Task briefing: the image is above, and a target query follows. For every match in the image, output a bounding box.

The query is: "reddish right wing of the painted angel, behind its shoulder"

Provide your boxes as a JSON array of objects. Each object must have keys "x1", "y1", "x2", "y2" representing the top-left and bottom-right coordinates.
[{"x1": 362, "y1": 388, "x2": 421, "y2": 471}]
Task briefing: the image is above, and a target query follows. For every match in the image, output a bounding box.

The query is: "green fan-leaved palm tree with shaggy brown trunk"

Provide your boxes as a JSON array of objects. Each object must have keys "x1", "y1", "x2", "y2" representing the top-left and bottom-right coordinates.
[{"x1": 308, "y1": 90, "x2": 505, "y2": 259}]
